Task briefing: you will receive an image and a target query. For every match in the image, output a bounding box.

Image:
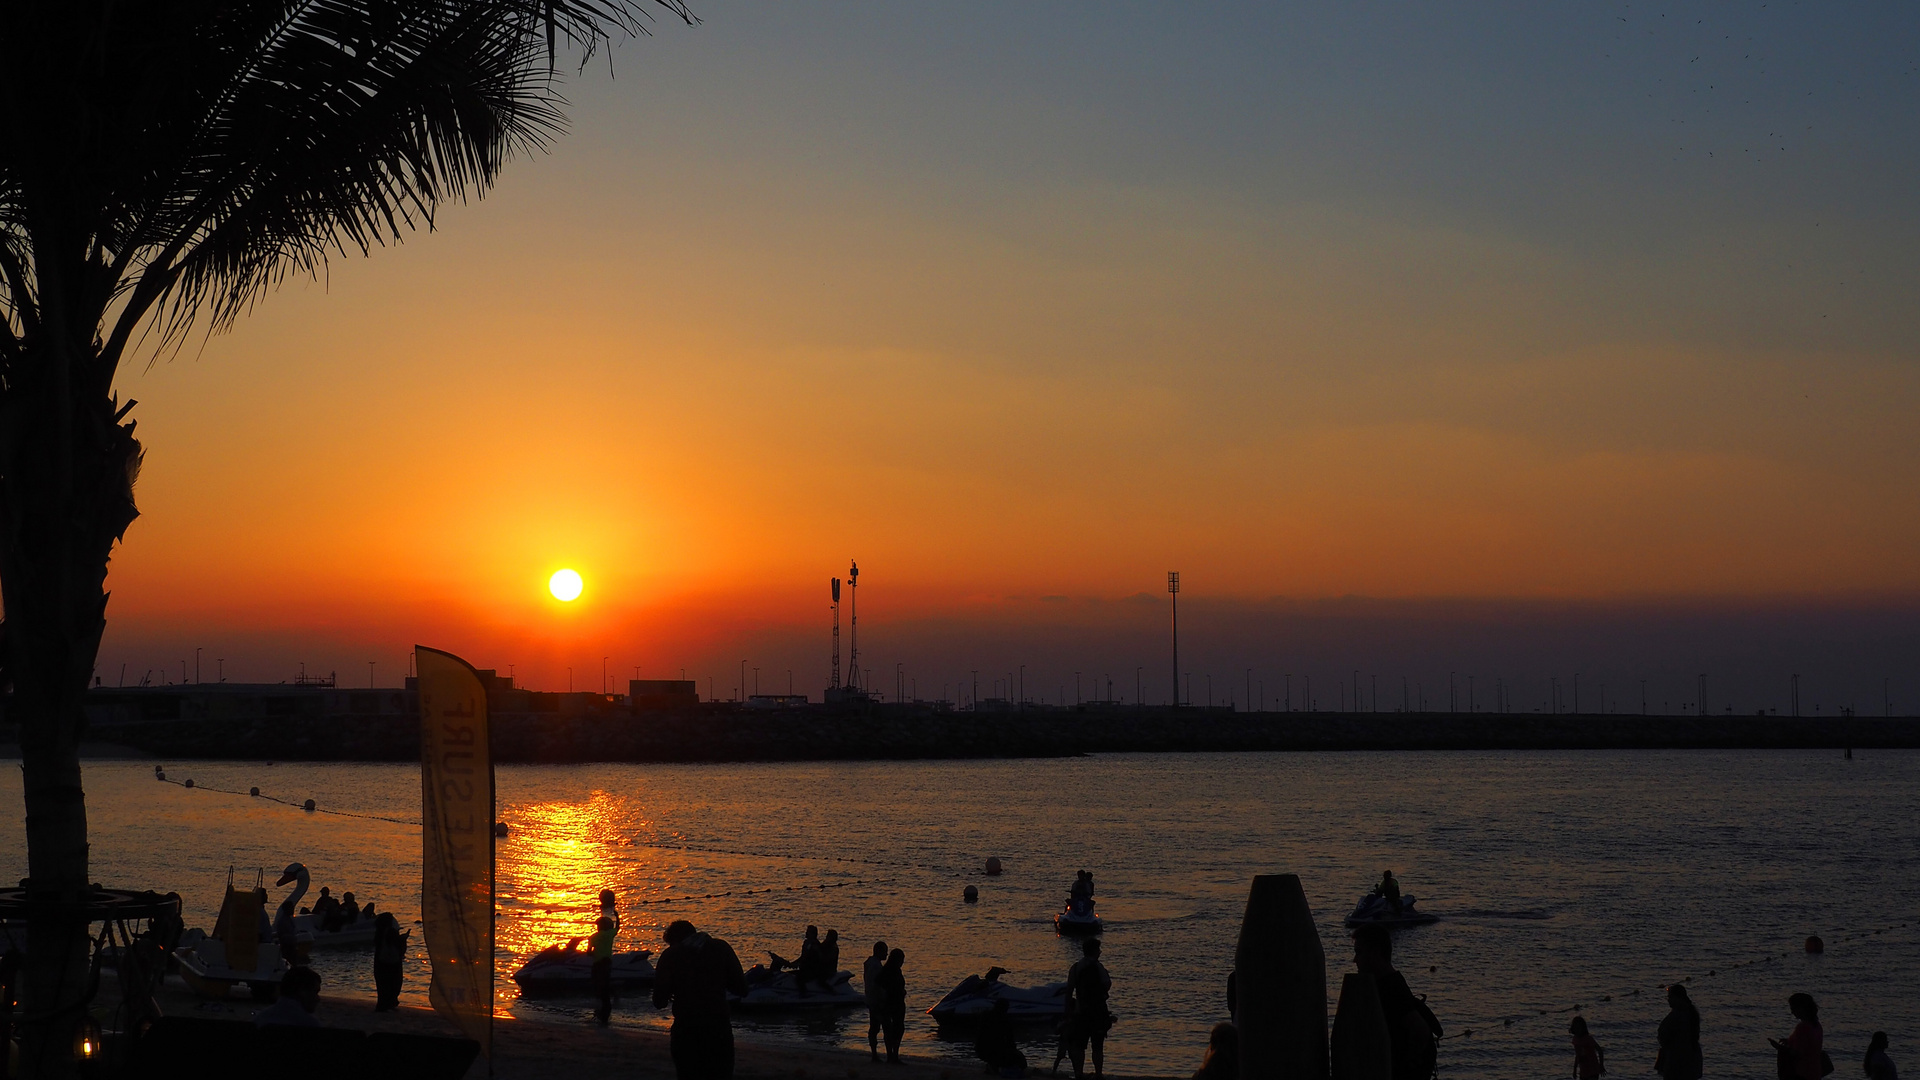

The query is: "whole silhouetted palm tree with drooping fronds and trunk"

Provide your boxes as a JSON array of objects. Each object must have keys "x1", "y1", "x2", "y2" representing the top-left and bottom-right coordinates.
[{"x1": 0, "y1": 0, "x2": 691, "y2": 1076}]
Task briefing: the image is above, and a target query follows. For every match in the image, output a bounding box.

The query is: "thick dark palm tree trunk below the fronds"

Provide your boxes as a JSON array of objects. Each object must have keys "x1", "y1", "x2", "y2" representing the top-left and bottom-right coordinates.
[{"x1": 0, "y1": 322, "x2": 140, "y2": 1076}]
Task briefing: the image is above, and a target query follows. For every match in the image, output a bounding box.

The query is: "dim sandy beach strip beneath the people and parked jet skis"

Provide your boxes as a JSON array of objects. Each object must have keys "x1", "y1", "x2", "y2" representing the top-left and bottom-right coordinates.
[{"x1": 157, "y1": 982, "x2": 1167, "y2": 1080}]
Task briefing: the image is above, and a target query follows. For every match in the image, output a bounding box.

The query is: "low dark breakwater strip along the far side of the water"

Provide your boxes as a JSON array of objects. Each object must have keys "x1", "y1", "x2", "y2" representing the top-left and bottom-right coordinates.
[{"x1": 18, "y1": 705, "x2": 1920, "y2": 765}]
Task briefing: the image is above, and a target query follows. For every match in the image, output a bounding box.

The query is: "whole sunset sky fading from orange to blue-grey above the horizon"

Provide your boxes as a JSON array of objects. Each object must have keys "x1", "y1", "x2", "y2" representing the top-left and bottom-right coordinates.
[{"x1": 100, "y1": 2, "x2": 1920, "y2": 711}]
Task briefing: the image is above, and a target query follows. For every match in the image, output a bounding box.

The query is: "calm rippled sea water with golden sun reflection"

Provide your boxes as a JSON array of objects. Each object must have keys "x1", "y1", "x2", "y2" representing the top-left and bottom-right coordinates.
[{"x1": 0, "y1": 751, "x2": 1920, "y2": 1080}]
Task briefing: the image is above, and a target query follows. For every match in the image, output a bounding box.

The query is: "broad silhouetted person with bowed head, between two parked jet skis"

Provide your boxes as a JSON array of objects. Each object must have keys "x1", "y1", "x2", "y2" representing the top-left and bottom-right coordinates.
[{"x1": 653, "y1": 919, "x2": 747, "y2": 1080}]
